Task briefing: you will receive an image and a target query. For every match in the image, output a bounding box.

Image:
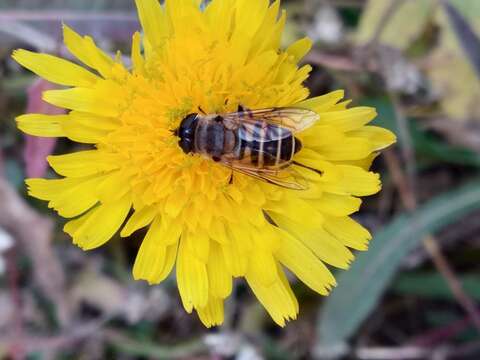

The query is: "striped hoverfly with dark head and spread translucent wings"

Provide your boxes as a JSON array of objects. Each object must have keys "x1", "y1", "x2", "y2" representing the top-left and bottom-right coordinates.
[{"x1": 174, "y1": 106, "x2": 319, "y2": 190}]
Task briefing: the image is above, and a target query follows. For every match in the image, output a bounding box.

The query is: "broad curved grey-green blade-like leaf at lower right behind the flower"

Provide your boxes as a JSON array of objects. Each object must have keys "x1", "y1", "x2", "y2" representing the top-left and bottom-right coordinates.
[{"x1": 318, "y1": 180, "x2": 480, "y2": 347}]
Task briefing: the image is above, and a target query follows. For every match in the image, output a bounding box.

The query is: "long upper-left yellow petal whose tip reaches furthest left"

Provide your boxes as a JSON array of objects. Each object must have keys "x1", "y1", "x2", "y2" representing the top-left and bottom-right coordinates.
[{"x1": 13, "y1": 50, "x2": 98, "y2": 87}]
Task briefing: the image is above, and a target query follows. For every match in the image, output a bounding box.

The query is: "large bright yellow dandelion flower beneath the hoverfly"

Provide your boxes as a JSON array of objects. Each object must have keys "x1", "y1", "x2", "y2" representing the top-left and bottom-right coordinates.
[{"x1": 13, "y1": 0, "x2": 395, "y2": 326}]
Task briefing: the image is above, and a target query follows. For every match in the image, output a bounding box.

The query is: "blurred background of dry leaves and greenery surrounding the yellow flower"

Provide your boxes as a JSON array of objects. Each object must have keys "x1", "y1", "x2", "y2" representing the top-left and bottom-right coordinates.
[{"x1": 0, "y1": 0, "x2": 480, "y2": 360}]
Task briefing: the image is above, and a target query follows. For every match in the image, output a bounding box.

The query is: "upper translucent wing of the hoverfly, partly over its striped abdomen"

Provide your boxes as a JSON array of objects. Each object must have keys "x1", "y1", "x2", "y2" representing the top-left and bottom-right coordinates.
[{"x1": 220, "y1": 108, "x2": 320, "y2": 142}]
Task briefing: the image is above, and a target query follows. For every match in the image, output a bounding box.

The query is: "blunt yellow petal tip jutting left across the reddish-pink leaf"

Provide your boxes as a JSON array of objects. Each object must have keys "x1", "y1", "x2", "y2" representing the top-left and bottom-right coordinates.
[{"x1": 15, "y1": 114, "x2": 68, "y2": 137}]
